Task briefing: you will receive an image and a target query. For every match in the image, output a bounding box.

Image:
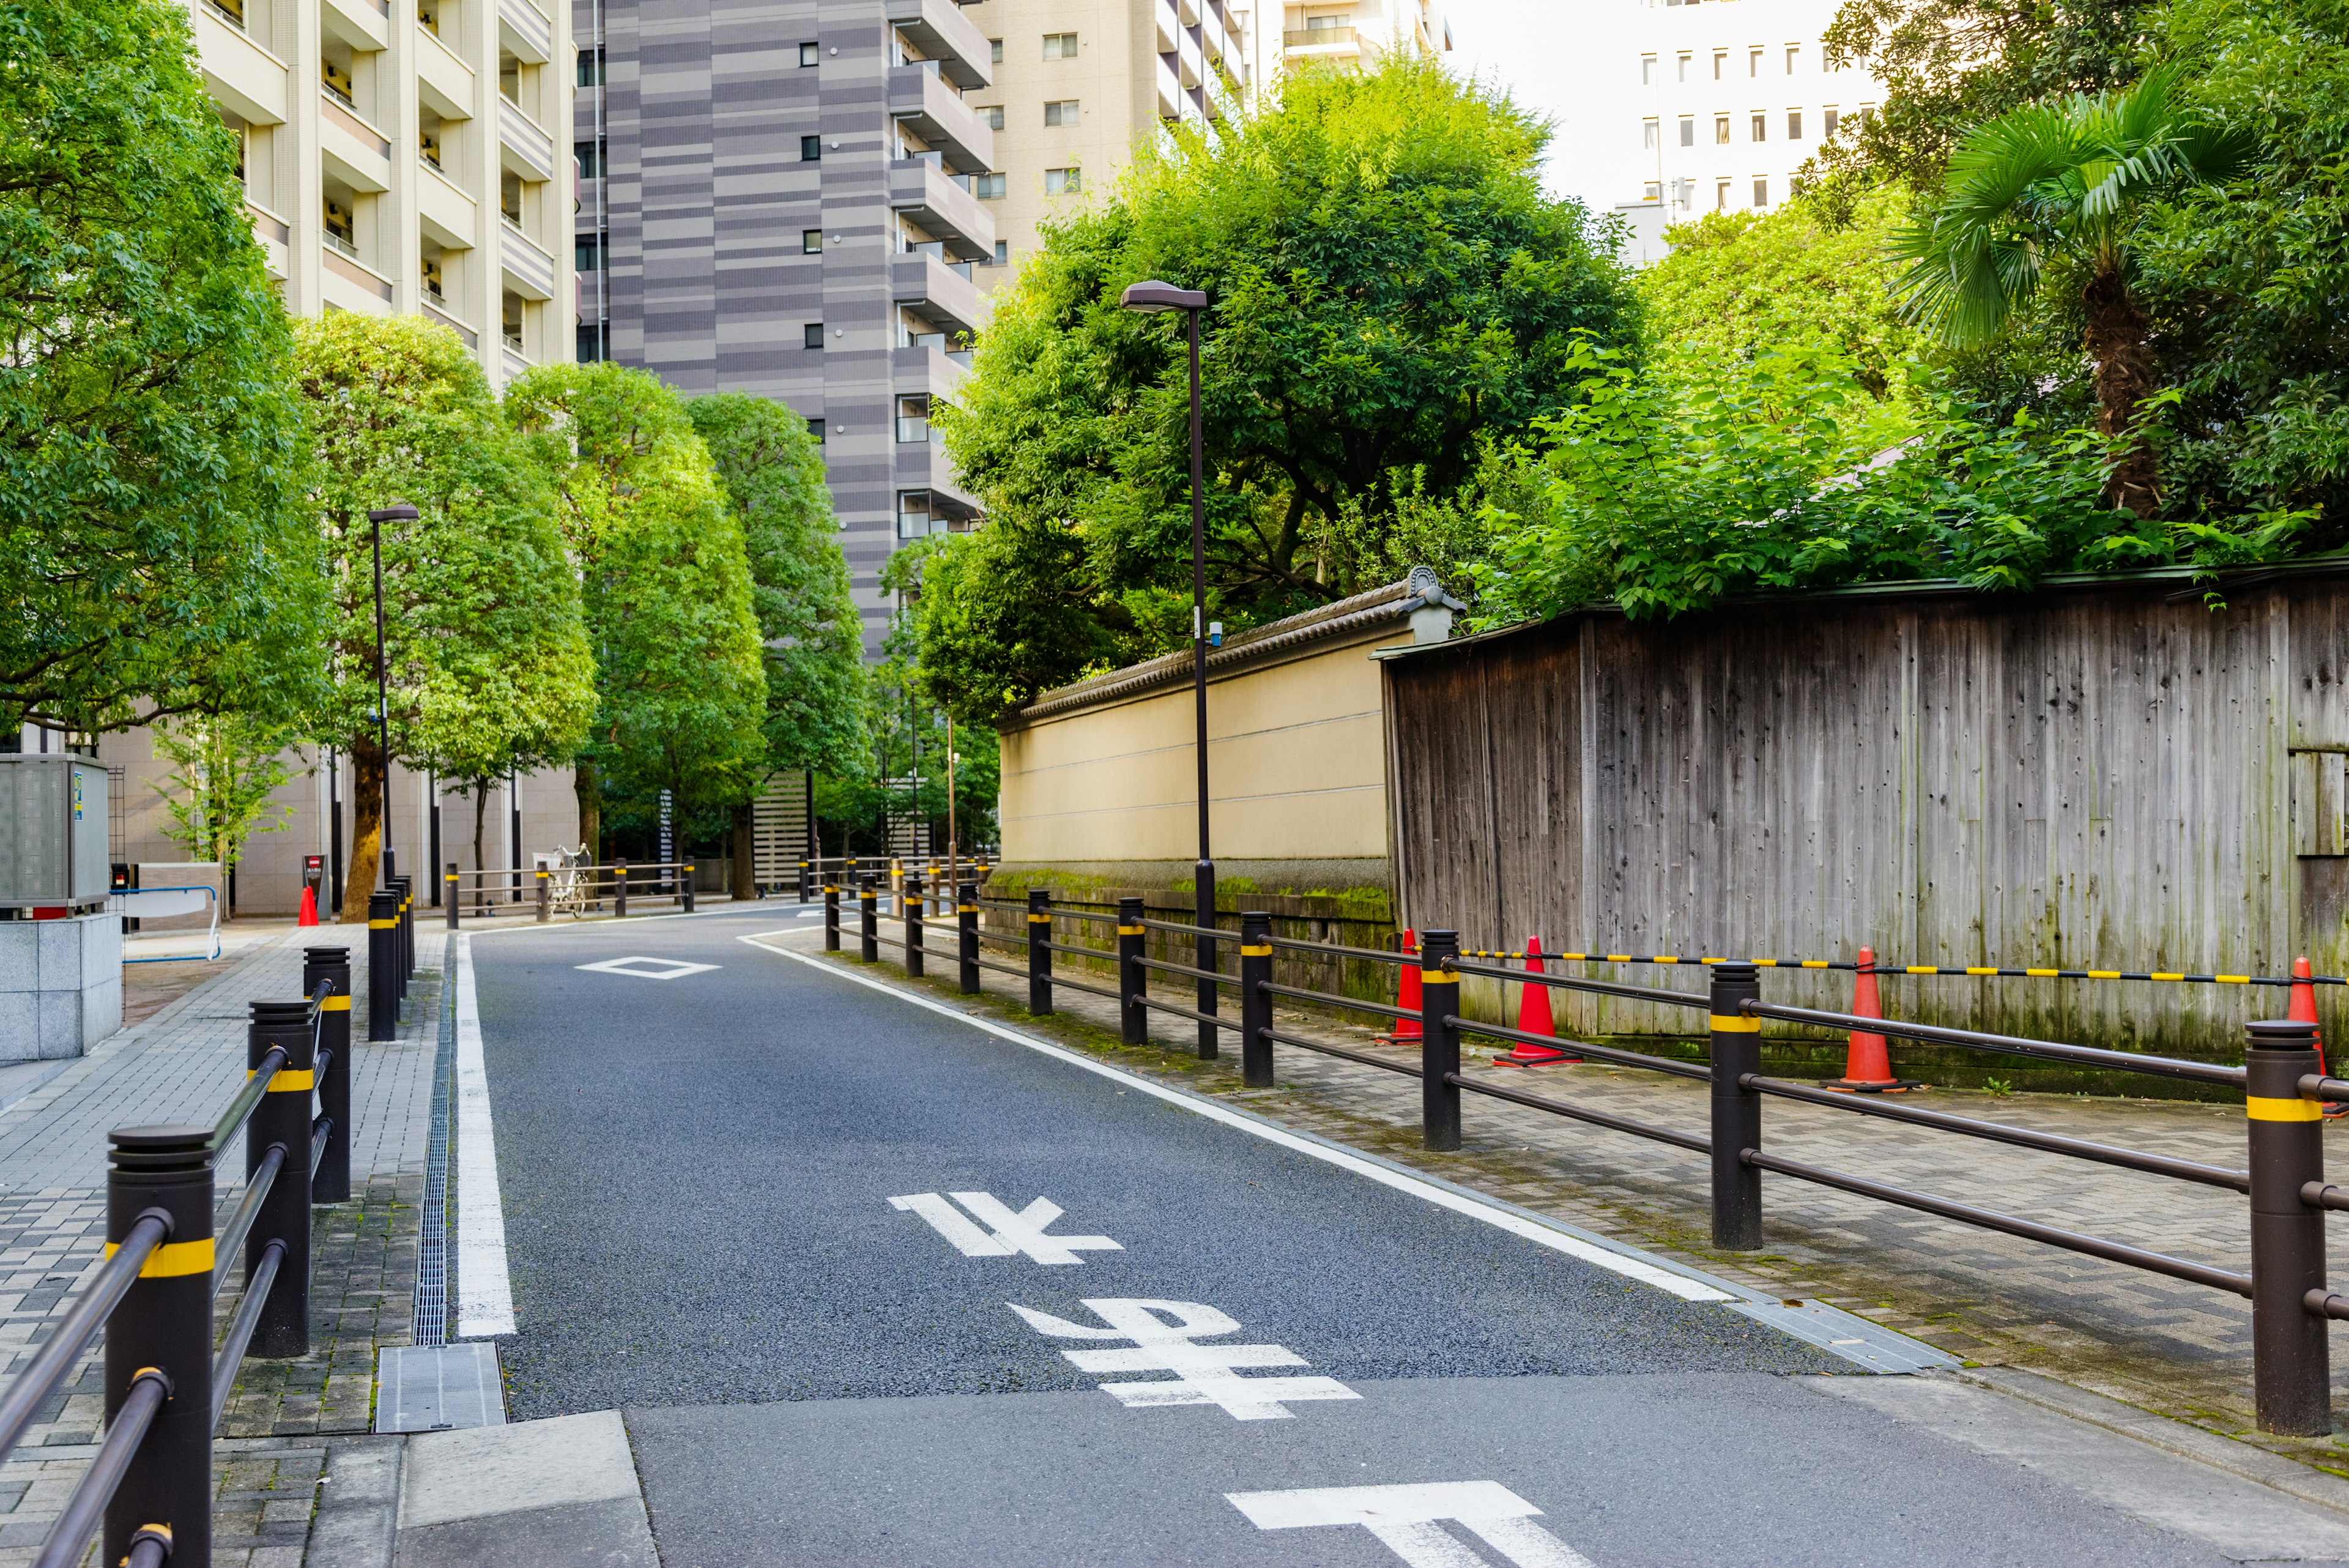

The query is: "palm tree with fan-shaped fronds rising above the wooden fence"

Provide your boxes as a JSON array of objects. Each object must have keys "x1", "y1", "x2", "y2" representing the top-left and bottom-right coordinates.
[{"x1": 1891, "y1": 66, "x2": 2251, "y2": 517}]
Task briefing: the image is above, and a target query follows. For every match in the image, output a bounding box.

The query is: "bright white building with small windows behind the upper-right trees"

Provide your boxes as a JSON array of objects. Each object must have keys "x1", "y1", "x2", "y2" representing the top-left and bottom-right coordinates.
[{"x1": 1606, "y1": 0, "x2": 1882, "y2": 261}]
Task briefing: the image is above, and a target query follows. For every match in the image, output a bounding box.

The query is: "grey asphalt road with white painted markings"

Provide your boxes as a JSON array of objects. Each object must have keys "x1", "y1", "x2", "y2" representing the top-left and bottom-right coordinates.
[{"x1": 458, "y1": 905, "x2": 2349, "y2": 1568}]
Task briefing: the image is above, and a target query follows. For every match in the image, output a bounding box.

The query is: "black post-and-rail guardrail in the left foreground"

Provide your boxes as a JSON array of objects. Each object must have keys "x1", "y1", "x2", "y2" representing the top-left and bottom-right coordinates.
[{"x1": 0, "y1": 948, "x2": 357, "y2": 1568}]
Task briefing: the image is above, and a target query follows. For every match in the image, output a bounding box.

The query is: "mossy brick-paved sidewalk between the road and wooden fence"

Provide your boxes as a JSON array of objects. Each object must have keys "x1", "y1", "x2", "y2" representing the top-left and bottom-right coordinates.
[{"x1": 789, "y1": 931, "x2": 2349, "y2": 1471}]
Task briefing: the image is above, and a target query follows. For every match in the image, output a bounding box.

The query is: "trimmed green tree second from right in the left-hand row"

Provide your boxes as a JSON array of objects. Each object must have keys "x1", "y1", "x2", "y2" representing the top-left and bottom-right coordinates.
[{"x1": 505, "y1": 362, "x2": 766, "y2": 853}]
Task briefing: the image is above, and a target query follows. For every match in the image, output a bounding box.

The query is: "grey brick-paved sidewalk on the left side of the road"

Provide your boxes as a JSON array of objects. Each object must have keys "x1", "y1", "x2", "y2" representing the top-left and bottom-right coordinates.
[{"x1": 0, "y1": 926, "x2": 442, "y2": 1568}]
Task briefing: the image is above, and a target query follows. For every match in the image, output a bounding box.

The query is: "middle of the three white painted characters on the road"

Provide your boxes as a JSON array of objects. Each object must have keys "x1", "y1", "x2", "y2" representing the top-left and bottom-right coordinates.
[{"x1": 1006, "y1": 1298, "x2": 1360, "y2": 1420}]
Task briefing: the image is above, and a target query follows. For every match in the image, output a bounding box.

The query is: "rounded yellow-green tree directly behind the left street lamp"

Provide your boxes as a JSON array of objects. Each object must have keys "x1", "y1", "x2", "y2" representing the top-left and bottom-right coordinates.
[{"x1": 299, "y1": 313, "x2": 595, "y2": 921}]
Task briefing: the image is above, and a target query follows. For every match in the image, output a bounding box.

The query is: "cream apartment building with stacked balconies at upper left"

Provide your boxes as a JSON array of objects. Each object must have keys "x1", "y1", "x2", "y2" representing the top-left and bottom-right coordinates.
[{"x1": 188, "y1": 0, "x2": 576, "y2": 385}]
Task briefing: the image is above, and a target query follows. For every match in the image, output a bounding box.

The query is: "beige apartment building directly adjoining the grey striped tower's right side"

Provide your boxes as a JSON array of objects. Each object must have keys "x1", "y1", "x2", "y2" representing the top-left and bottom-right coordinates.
[{"x1": 963, "y1": 0, "x2": 1255, "y2": 278}]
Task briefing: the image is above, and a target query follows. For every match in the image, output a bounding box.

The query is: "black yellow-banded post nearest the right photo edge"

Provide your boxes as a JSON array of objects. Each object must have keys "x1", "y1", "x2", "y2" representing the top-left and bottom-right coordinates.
[{"x1": 2243, "y1": 1018, "x2": 2332, "y2": 1436}]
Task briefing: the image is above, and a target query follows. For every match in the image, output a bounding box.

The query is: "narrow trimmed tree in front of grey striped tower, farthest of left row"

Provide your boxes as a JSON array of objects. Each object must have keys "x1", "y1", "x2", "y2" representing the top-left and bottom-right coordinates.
[{"x1": 686, "y1": 393, "x2": 867, "y2": 898}]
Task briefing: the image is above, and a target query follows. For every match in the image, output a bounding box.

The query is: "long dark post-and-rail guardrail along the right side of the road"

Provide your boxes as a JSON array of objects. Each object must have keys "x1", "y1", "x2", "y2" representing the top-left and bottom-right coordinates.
[{"x1": 850, "y1": 877, "x2": 2349, "y2": 1434}]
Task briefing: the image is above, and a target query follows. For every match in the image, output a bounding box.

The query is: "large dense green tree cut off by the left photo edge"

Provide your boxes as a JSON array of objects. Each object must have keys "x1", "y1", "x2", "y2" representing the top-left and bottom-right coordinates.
[{"x1": 0, "y1": 0, "x2": 319, "y2": 731}]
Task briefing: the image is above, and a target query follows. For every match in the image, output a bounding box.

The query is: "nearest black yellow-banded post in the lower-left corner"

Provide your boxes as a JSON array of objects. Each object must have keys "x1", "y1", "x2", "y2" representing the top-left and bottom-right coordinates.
[{"x1": 98, "y1": 1126, "x2": 213, "y2": 1566}]
